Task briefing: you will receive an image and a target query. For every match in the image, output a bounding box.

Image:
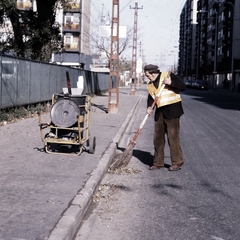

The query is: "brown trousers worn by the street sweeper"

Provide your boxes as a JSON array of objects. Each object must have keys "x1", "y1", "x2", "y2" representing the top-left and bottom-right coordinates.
[{"x1": 153, "y1": 112, "x2": 183, "y2": 166}]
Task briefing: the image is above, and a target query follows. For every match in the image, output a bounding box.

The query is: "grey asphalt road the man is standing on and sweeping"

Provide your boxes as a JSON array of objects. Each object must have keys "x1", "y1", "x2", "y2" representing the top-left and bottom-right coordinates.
[{"x1": 75, "y1": 89, "x2": 240, "y2": 240}]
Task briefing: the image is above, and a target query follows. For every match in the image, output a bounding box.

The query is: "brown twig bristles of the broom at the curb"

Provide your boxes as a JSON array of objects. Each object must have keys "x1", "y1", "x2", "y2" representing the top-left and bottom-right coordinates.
[{"x1": 110, "y1": 141, "x2": 136, "y2": 170}]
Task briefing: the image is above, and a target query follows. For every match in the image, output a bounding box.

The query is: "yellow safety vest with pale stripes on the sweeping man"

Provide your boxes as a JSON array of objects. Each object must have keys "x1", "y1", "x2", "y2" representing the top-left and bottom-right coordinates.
[{"x1": 147, "y1": 72, "x2": 182, "y2": 108}]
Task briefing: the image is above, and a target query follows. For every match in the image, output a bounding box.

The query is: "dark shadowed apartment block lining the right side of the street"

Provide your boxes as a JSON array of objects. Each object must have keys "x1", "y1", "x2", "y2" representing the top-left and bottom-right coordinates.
[{"x1": 178, "y1": 0, "x2": 240, "y2": 90}]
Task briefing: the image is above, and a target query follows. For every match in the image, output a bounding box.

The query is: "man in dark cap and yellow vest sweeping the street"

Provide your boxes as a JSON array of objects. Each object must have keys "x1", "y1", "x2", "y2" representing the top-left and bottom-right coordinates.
[{"x1": 144, "y1": 64, "x2": 186, "y2": 171}]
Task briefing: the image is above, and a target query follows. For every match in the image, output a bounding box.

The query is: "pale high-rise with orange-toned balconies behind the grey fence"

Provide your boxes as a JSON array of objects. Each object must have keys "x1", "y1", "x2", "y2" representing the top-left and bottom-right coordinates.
[{"x1": 52, "y1": 0, "x2": 92, "y2": 70}]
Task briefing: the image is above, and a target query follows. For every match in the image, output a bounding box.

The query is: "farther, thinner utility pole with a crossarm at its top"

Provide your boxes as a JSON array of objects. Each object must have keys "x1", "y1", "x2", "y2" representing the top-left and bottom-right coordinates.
[{"x1": 130, "y1": 2, "x2": 143, "y2": 94}]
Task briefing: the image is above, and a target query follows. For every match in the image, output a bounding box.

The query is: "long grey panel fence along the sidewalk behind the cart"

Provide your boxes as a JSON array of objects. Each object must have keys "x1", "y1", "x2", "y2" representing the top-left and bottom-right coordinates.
[{"x1": 0, "y1": 55, "x2": 109, "y2": 109}]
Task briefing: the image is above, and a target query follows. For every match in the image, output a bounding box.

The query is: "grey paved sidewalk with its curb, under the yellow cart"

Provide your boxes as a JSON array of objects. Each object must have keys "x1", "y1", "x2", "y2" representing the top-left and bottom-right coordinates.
[{"x1": 0, "y1": 86, "x2": 145, "y2": 240}]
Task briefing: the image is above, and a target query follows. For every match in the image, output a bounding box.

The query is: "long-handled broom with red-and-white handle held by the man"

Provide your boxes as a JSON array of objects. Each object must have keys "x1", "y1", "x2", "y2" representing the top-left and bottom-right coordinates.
[{"x1": 110, "y1": 84, "x2": 165, "y2": 170}]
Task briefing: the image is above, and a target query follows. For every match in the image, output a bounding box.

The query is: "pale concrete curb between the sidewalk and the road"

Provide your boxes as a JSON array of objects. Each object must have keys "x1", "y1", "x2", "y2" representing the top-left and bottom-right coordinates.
[{"x1": 47, "y1": 95, "x2": 142, "y2": 240}]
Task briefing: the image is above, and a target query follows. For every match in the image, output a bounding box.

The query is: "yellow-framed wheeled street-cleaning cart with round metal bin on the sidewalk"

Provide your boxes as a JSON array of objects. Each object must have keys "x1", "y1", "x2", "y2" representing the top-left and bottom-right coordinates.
[{"x1": 39, "y1": 93, "x2": 96, "y2": 155}]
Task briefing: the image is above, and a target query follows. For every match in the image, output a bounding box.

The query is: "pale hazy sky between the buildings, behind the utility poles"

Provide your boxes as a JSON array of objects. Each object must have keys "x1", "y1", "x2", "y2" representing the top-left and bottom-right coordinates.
[{"x1": 91, "y1": 0, "x2": 186, "y2": 71}]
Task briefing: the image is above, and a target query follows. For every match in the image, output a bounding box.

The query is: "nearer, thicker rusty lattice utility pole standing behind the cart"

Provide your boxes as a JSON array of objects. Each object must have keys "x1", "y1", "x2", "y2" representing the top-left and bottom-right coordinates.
[{"x1": 108, "y1": 0, "x2": 119, "y2": 113}]
